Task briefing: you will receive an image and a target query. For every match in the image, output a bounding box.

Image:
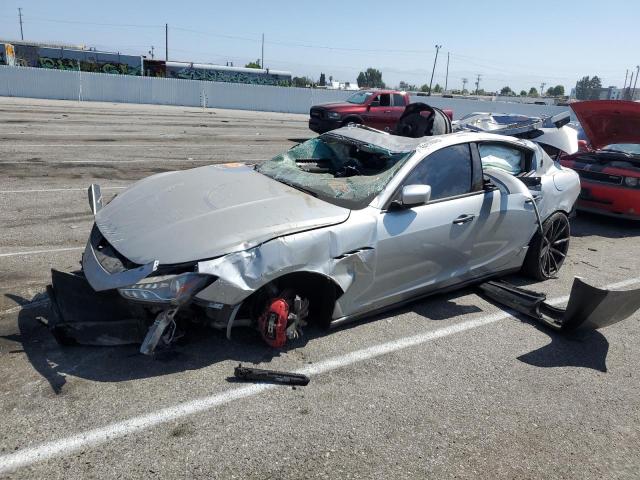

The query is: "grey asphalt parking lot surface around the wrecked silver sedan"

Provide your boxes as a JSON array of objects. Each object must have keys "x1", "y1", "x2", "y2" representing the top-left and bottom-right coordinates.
[{"x1": 0, "y1": 98, "x2": 640, "y2": 479}]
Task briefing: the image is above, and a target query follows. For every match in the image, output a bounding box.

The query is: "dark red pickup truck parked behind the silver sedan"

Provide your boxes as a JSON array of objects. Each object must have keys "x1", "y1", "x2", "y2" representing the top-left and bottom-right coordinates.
[{"x1": 309, "y1": 90, "x2": 410, "y2": 133}]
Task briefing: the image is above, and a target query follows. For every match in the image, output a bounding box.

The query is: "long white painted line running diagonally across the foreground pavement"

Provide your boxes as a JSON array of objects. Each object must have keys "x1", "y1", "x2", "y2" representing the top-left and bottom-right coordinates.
[{"x1": 0, "y1": 278, "x2": 640, "y2": 473}]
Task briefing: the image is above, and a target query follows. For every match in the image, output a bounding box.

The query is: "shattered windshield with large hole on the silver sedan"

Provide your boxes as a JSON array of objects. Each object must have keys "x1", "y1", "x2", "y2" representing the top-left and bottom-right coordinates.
[{"x1": 256, "y1": 134, "x2": 413, "y2": 209}]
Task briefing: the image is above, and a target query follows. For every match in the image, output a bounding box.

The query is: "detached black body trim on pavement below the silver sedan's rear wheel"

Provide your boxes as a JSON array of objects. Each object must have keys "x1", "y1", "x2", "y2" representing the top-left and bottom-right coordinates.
[{"x1": 479, "y1": 277, "x2": 640, "y2": 332}]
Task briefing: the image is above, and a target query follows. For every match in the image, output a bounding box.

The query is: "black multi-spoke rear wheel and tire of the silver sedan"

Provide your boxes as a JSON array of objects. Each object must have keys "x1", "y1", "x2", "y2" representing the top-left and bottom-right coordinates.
[{"x1": 522, "y1": 212, "x2": 571, "y2": 280}]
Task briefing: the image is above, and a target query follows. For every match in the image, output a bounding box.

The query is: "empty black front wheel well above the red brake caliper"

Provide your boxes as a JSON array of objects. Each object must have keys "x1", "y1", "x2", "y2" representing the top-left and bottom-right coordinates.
[{"x1": 238, "y1": 272, "x2": 344, "y2": 326}]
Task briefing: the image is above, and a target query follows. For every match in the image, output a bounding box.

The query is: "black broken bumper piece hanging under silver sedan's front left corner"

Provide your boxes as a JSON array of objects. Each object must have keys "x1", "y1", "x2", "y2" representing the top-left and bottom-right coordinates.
[{"x1": 47, "y1": 270, "x2": 147, "y2": 346}]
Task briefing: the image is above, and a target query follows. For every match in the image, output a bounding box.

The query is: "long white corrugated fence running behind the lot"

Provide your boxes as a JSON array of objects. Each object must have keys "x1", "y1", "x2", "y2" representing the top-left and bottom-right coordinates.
[{"x1": 0, "y1": 66, "x2": 568, "y2": 118}]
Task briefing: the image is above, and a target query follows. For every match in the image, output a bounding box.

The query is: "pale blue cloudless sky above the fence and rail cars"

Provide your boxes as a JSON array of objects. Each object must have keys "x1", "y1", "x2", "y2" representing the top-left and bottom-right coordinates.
[{"x1": 0, "y1": 0, "x2": 640, "y2": 92}]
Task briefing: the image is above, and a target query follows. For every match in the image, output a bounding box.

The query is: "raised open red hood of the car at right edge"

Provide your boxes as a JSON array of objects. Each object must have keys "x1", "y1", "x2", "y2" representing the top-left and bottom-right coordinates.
[{"x1": 571, "y1": 100, "x2": 640, "y2": 149}]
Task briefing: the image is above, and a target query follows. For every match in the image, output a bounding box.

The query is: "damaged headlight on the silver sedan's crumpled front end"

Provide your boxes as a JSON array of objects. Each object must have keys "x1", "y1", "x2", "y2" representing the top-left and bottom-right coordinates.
[{"x1": 118, "y1": 273, "x2": 215, "y2": 305}]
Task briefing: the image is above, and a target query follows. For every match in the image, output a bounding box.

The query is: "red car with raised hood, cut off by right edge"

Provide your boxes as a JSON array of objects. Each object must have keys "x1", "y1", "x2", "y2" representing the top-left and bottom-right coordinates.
[{"x1": 560, "y1": 100, "x2": 640, "y2": 220}]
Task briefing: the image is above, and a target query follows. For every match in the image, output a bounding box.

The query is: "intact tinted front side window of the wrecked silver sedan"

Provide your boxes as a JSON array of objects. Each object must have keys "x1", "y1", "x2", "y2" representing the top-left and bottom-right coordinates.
[{"x1": 404, "y1": 143, "x2": 472, "y2": 200}]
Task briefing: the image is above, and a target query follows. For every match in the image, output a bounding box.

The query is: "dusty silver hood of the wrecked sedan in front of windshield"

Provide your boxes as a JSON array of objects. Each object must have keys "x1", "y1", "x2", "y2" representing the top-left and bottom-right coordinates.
[{"x1": 96, "y1": 164, "x2": 349, "y2": 265}]
